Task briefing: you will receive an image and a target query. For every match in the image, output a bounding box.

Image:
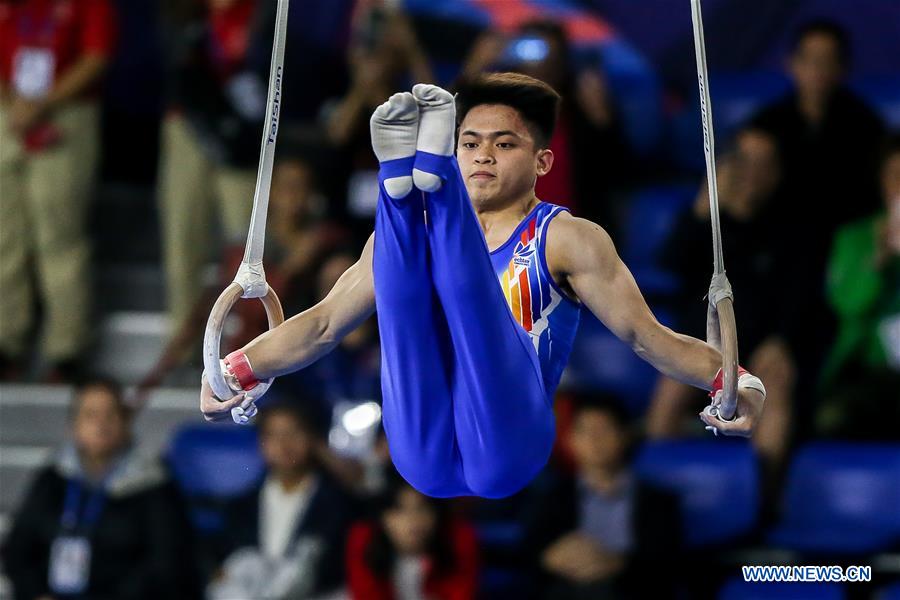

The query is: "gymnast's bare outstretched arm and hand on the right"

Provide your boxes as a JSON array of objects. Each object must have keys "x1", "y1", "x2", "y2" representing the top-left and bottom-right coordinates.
[{"x1": 547, "y1": 214, "x2": 765, "y2": 435}]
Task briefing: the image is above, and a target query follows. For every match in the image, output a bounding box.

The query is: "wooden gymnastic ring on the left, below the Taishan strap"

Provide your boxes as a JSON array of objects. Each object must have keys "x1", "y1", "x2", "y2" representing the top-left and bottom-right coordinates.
[{"x1": 203, "y1": 281, "x2": 284, "y2": 400}]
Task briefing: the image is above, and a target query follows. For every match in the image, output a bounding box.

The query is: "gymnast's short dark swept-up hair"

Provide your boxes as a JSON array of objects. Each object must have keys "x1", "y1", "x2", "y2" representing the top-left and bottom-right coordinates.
[{"x1": 456, "y1": 73, "x2": 560, "y2": 148}]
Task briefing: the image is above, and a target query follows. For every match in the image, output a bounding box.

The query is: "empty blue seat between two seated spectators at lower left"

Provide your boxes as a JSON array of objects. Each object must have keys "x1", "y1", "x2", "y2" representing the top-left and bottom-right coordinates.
[{"x1": 167, "y1": 425, "x2": 264, "y2": 498}]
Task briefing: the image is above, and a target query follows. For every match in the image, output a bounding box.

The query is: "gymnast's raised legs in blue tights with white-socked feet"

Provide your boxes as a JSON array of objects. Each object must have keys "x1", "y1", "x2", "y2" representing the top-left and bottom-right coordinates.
[{"x1": 372, "y1": 86, "x2": 555, "y2": 497}]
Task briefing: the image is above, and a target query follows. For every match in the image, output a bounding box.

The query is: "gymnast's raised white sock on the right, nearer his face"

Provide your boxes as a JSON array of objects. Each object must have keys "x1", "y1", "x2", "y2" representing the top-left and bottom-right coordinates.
[{"x1": 413, "y1": 83, "x2": 456, "y2": 192}]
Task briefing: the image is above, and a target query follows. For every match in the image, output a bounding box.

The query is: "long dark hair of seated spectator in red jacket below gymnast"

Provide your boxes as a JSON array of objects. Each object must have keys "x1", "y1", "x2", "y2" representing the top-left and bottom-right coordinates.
[{"x1": 363, "y1": 470, "x2": 456, "y2": 580}]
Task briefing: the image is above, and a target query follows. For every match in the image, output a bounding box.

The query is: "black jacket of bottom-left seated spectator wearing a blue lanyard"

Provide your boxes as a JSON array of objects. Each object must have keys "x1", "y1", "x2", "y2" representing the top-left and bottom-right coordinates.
[{"x1": 3, "y1": 451, "x2": 198, "y2": 600}]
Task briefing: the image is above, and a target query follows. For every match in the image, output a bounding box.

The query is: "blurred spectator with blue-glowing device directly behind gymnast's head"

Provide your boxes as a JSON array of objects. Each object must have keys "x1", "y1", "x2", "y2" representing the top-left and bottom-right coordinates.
[{"x1": 462, "y1": 21, "x2": 630, "y2": 233}]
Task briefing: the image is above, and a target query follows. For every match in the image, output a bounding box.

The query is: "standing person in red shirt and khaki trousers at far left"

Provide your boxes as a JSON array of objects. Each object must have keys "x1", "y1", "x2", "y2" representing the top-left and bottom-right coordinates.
[{"x1": 0, "y1": 0, "x2": 115, "y2": 380}]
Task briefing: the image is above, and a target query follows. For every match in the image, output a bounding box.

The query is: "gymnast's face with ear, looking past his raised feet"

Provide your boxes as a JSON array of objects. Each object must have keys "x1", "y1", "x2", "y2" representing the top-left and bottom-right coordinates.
[{"x1": 456, "y1": 104, "x2": 553, "y2": 210}]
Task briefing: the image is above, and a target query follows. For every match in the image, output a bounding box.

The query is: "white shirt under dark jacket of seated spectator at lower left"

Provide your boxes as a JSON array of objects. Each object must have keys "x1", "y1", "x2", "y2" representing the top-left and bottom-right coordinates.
[{"x1": 259, "y1": 475, "x2": 318, "y2": 558}]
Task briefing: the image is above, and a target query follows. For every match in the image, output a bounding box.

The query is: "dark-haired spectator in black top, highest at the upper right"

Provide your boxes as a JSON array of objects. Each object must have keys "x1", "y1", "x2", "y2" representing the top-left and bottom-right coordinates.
[{"x1": 753, "y1": 21, "x2": 884, "y2": 230}]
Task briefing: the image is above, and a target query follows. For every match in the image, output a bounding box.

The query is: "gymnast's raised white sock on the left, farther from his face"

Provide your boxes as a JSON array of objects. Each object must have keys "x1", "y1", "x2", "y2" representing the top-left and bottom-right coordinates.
[{"x1": 369, "y1": 92, "x2": 419, "y2": 200}]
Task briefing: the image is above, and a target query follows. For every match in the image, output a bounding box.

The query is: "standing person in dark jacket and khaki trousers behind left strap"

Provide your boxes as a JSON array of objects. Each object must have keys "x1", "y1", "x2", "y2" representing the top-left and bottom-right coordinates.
[{"x1": 159, "y1": 0, "x2": 272, "y2": 346}]
